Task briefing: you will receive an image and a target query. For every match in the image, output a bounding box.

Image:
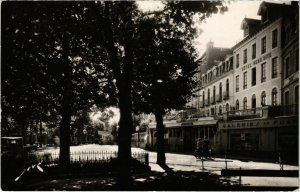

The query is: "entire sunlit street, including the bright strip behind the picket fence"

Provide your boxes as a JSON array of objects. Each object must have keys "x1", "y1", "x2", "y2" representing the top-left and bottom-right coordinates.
[{"x1": 40, "y1": 144, "x2": 299, "y2": 186}]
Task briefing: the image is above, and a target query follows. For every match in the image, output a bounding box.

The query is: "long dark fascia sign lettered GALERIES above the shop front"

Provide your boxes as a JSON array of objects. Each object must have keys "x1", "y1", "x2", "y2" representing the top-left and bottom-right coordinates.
[{"x1": 219, "y1": 118, "x2": 299, "y2": 129}]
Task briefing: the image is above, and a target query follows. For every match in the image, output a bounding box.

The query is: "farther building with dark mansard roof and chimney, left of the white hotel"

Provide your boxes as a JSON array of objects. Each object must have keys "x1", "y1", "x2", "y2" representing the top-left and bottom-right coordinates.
[{"x1": 187, "y1": 41, "x2": 233, "y2": 112}]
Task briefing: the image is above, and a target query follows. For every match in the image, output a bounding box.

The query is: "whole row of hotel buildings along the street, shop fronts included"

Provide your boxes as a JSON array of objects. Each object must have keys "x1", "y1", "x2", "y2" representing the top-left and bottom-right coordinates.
[{"x1": 149, "y1": 2, "x2": 299, "y2": 159}]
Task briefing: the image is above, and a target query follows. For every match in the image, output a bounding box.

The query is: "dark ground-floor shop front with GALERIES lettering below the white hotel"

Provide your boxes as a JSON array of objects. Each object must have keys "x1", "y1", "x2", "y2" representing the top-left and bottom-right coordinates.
[{"x1": 218, "y1": 116, "x2": 299, "y2": 160}]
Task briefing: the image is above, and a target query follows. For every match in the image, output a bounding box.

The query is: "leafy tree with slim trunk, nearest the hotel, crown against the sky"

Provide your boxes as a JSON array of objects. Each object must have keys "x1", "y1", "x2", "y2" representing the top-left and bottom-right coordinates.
[{"x1": 134, "y1": 1, "x2": 226, "y2": 166}]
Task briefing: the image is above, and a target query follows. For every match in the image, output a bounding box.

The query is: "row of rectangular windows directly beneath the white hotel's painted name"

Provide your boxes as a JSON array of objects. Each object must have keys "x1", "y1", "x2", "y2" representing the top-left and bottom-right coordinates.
[{"x1": 235, "y1": 57, "x2": 278, "y2": 92}]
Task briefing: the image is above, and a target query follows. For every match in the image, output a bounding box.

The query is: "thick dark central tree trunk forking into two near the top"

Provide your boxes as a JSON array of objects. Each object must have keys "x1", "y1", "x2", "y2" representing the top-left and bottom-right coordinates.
[{"x1": 103, "y1": 1, "x2": 133, "y2": 190}]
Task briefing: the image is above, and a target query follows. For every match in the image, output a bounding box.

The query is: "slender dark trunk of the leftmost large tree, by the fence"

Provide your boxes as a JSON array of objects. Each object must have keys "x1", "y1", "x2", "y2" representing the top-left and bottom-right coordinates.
[{"x1": 59, "y1": 33, "x2": 72, "y2": 169}]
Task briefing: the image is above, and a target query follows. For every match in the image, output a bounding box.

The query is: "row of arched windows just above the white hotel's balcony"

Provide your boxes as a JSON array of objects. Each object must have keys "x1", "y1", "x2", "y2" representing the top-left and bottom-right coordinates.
[{"x1": 235, "y1": 88, "x2": 278, "y2": 110}]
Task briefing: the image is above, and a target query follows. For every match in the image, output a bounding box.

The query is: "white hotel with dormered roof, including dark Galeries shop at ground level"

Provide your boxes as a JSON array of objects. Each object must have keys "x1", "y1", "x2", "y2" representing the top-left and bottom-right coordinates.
[{"x1": 218, "y1": 2, "x2": 298, "y2": 160}]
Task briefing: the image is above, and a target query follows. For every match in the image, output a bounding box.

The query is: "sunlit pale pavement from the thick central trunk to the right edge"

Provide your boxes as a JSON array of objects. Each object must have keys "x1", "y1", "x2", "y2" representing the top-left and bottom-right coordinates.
[{"x1": 149, "y1": 152, "x2": 299, "y2": 187}]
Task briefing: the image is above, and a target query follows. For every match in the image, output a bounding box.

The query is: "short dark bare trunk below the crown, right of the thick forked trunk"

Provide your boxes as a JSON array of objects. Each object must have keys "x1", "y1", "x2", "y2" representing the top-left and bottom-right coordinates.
[{"x1": 155, "y1": 110, "x2": 166, "y2": 165}]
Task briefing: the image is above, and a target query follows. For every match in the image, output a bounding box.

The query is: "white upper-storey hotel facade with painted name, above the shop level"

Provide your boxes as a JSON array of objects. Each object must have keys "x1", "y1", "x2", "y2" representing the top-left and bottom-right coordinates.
[{"x1": 233, "y1": 15, "x2": 282, "y2": 110}]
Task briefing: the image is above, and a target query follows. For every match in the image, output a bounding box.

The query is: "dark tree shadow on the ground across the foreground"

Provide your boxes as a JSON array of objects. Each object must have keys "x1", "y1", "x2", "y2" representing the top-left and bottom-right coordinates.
[{"x1": 8, "y1": 170, "x2": 295, "y2": 191}]
